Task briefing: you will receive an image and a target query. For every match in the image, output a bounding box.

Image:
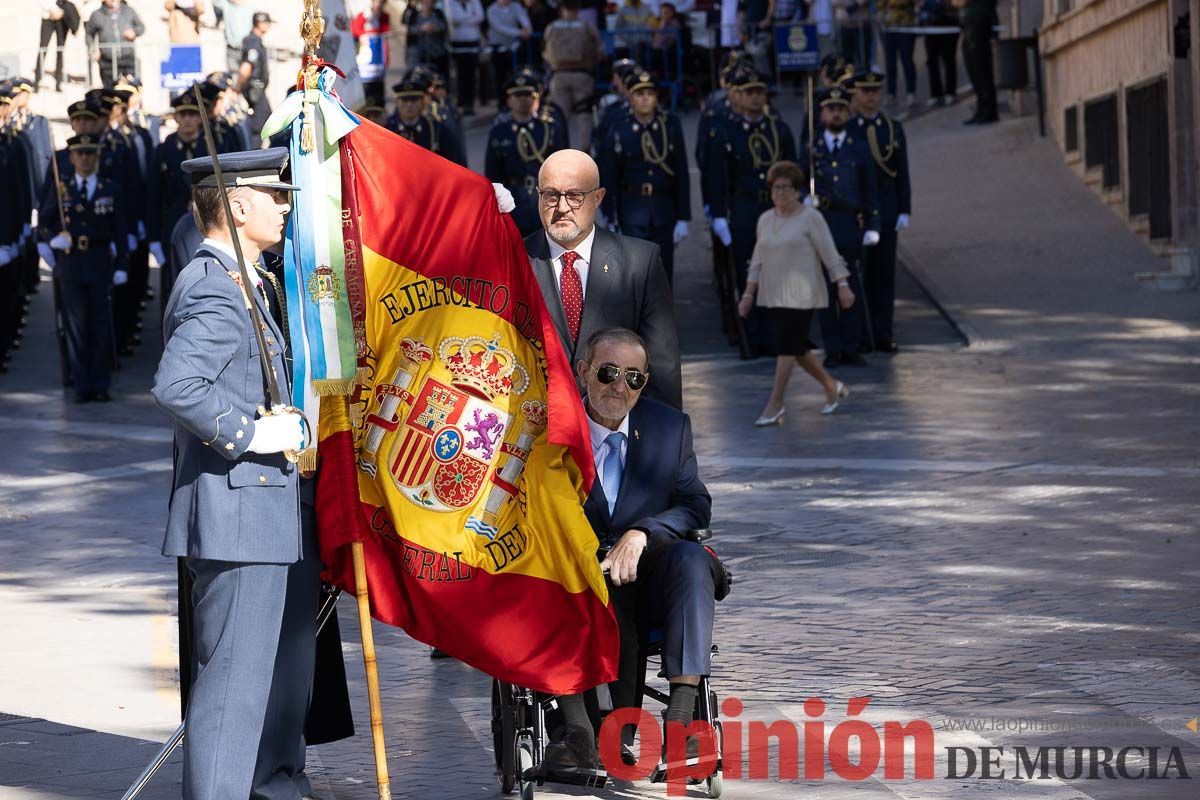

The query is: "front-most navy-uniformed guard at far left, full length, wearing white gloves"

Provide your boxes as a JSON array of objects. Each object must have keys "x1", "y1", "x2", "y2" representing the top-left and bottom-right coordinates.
[{"x1": 37, "y1": 136, "x2": 128, "y2": 403}]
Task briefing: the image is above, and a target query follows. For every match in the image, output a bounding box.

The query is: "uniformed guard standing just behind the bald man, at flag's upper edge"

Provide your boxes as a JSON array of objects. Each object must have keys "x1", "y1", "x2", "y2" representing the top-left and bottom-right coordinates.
[{"x1": 484, "y1": 72, "x2": 566, "y2": 236}]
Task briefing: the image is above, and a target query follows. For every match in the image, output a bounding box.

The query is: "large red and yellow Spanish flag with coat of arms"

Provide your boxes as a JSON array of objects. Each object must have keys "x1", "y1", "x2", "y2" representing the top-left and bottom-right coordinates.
[{"x1": 317, "y1": 120, "x2": 619, "y2": 693}]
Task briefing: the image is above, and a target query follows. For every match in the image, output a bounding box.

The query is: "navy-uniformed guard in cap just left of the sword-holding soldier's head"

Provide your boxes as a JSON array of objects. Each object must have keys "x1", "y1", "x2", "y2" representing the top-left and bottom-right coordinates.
[{"x1": 148, "y1": 91, "x2": 212, "y2": 307}]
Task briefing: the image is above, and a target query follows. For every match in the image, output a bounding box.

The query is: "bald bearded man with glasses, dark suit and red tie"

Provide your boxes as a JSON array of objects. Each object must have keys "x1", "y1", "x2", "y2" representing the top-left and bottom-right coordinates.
[{"x1": 526, "y1": 150, "x2": 683, "y2": 409}]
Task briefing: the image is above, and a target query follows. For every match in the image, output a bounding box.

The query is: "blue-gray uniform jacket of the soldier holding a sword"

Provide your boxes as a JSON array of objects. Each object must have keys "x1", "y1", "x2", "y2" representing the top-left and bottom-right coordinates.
[{"x1": 154, "y1": 246, "x2": 300, "y2": 564}]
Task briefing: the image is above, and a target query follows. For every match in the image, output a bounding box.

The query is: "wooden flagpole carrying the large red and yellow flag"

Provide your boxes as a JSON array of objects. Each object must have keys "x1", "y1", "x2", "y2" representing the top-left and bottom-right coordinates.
[{"x1": 300, "y1": 0, "x2": 391, "y2": 800}]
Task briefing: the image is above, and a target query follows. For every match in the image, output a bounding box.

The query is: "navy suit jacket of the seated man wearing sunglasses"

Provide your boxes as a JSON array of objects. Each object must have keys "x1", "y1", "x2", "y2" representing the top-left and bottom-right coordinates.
[{"x1": 583, "y1": 397, "x2": 713, "y2": 552}]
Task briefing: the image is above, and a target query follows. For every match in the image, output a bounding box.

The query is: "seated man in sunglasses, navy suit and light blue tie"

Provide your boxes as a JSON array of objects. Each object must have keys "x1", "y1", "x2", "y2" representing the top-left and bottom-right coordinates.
[{"x1": 544, "y1": 327, "x2": 721, "y2": 775}]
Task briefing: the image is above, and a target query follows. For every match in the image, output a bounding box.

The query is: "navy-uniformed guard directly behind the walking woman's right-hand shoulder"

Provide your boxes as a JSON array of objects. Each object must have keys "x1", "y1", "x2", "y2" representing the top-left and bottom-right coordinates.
[{"x1": 811, "y1": 86, "x2": 880, "y2": 367}]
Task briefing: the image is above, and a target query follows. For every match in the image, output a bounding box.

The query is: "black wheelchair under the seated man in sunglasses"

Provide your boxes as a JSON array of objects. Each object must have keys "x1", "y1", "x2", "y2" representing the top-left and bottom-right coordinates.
[{"x1": 492, "y1": 529, "x2": 732, "y2": 800}]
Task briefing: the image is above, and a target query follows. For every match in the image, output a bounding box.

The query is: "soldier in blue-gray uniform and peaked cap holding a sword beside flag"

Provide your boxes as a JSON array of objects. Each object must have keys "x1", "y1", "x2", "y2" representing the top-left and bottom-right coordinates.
[{"x1": 154, "y1": 148, "x2": 320, "y2": 800}]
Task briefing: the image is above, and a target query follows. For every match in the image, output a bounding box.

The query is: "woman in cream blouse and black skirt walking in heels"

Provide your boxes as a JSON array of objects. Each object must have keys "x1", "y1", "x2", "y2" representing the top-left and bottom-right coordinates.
[{"x1": 738, "y1": 161, "x2": 854, "y2": 427}]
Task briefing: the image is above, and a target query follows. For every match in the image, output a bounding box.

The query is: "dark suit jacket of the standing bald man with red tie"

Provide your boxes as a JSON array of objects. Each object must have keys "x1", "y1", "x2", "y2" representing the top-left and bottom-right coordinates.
[{"x1": 526, "y1": 228, "x2": 683, "y2": 409}]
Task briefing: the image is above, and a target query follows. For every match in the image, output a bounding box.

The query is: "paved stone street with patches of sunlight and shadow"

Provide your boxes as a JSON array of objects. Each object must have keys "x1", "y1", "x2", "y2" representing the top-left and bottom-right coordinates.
[{"x1": 0, "y1": 94, "x2": 1200, "y2": 800}]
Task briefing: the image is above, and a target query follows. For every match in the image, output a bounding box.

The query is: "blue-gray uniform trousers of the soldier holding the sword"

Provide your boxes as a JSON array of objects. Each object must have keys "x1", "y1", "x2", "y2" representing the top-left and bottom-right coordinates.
[{"x1": 184, "y1": 506, "x2": 320, "y2": 800}]
